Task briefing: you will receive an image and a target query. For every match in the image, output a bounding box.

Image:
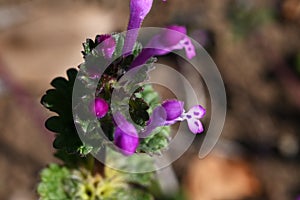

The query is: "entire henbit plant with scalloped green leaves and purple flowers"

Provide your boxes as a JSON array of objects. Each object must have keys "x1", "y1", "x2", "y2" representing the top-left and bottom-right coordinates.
[{"x1": 37, "y1": 0, "x2": 205, "y2": 200}]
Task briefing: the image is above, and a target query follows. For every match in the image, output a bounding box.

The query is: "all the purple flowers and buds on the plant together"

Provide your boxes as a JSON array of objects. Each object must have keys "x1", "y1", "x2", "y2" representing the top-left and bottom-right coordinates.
[{"x1": 93, "y1": 0, "x2": 205, "y2": 156}]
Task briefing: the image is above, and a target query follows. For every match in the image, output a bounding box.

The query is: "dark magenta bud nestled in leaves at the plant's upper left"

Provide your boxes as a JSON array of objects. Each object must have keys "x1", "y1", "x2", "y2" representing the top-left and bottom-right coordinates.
[{"x1": 96, "y1": 35, "x2": 116, "y2": 59}]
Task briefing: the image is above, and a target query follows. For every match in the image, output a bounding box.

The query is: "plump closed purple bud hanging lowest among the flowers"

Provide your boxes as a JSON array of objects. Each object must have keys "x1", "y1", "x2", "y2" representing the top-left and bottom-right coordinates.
[{"x1": 114, "y1": 113, "x2": 139, "y2": 156}]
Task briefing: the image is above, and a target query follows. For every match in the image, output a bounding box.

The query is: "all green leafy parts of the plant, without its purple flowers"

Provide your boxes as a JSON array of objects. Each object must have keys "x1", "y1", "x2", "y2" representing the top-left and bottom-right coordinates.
[{"x1": 38, "y1": 30, "x2": 175, "y2": 200}]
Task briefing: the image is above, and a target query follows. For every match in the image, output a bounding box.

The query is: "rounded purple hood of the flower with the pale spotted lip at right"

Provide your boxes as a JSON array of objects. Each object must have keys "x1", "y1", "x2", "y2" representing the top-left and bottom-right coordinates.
[{"x1": 162, "y1": 99, "x2": 184, "y2": 121}]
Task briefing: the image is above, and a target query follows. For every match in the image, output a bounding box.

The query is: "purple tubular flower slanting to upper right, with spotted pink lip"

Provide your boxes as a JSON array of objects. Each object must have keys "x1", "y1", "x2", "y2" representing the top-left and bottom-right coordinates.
[{"x1": 131, "y1": 25, "x2": 196, "y2": 68}]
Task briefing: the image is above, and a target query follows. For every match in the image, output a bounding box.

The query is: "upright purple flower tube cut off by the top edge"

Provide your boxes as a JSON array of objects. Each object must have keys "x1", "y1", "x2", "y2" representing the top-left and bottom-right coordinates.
[{"x1": 123, "y1": 0, "x2": 166, "y2": 54}]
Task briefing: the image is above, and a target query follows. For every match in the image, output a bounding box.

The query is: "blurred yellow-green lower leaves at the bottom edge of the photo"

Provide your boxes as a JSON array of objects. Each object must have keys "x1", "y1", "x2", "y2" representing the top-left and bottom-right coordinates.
[{"x1": 38, "y1": 164, "x2": 154, "y2": 200}]
